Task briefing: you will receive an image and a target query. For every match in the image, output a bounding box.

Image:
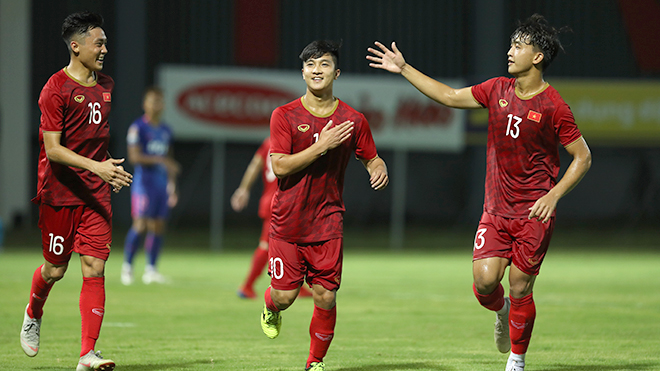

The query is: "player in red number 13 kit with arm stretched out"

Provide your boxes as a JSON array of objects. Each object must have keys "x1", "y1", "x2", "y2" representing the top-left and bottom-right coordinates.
[{"x1": 367, "y1": 14, "x2": 591, "y2": 371}]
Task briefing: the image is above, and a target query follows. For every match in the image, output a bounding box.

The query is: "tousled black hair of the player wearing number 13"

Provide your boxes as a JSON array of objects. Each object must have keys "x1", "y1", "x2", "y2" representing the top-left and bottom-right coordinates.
[{"x1": 511, "y1": 14, "x2": 570, "y2": 71}]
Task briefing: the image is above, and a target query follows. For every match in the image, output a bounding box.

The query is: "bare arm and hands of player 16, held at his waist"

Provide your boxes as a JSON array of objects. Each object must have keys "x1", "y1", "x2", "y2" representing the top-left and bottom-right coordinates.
[{"x1": 43, "y1": 131, "x2": 133, "y2": 192}]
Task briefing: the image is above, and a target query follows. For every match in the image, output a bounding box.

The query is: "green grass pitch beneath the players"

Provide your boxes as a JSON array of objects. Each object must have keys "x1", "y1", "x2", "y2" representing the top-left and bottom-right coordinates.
[{"x1": 0, "y1": 227, "x2": 660, "y2": 371}]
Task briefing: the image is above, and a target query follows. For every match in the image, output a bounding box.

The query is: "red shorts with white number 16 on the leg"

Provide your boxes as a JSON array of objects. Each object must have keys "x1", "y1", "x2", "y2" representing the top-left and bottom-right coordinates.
[{"x1": 39, "y1": 203, "x2": 112, "y2": 265}]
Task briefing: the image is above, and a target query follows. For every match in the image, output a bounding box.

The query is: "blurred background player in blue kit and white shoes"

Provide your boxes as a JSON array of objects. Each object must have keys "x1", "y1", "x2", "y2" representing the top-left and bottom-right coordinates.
[{"x1": 121, "y1": 87, "x2": 180, "y2": 285}]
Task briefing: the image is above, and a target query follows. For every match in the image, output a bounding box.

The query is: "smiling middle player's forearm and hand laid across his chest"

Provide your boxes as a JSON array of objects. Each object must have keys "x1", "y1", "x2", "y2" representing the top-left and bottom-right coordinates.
[{"x1": 270, "y1": 120, "x2": 355, "y2": 178}]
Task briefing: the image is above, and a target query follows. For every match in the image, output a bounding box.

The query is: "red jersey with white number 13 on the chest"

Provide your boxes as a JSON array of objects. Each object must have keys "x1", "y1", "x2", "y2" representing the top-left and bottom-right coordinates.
[{"x1": 472, "y1": 77, "x2": 582, "y2": 218}]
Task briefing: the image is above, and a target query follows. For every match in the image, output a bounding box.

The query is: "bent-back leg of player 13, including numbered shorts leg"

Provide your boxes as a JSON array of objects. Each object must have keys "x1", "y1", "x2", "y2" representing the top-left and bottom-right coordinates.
[{"x1": 472, "y1": 212, "x2": 512, "y2": 353}]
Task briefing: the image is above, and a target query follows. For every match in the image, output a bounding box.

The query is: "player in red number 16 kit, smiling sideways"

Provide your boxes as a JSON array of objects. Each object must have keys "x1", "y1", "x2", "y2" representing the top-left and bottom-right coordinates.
[{"x1": 20, "y1": 12, "x2": 132, "y2": 371}]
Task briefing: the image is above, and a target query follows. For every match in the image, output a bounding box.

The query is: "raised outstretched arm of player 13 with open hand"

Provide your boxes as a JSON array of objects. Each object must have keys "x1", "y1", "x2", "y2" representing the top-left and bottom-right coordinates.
[{"x1": 367, "y1": 41, "x2": 481, "y2": 108}]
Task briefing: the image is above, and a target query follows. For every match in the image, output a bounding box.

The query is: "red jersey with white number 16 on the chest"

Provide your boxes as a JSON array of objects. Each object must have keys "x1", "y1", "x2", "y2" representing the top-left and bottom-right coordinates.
[{"x1": 33, "y1": 69, "x2": 115, "y2": 206}]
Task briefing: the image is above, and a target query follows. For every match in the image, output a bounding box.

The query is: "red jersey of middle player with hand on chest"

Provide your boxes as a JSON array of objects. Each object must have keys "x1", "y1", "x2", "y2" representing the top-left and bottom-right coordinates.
[{"x1": 270, "y1": 98, "x2": 378, "y2": 243}]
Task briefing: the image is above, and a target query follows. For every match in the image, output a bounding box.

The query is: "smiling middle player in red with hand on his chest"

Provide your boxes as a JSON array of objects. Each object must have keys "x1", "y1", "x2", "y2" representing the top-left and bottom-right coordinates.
[{"x1": 261, "y1": 41, "x2": 389, "y2": 371}]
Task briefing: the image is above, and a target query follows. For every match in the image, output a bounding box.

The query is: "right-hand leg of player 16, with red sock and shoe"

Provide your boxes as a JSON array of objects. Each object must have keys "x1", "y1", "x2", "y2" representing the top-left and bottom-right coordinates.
[{"x1": 74, "y1": 204, "x2": 114, "y2": 370}]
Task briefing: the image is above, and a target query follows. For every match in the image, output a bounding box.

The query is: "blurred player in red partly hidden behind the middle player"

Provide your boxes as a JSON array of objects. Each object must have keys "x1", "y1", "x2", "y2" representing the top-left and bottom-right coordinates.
[{"x1": 231, "y1": 137, "x2": 312, "y2": 299}]
